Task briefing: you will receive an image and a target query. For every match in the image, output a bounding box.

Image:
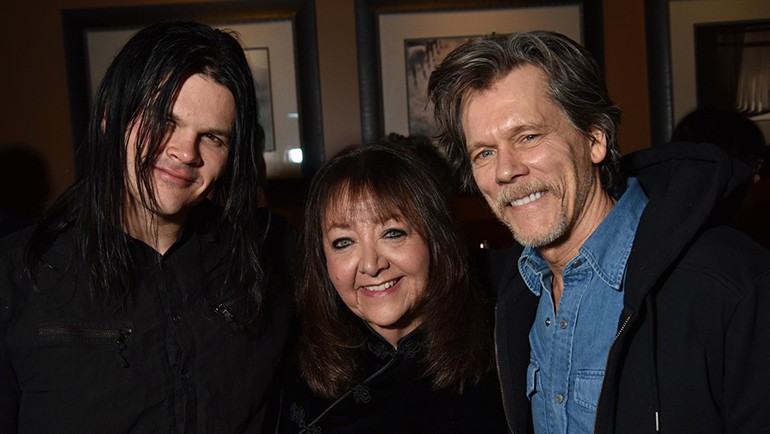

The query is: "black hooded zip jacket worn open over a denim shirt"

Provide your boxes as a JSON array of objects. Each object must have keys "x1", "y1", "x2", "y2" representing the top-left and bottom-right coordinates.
[{"x1": 490, "y1": 144, "x2": 770, "y2": 434}]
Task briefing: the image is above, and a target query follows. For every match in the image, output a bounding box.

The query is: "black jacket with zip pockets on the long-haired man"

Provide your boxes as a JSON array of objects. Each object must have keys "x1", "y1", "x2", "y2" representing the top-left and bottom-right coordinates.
[{"x1": 0, "y1": 205, "x2": 294, "y2": 433}]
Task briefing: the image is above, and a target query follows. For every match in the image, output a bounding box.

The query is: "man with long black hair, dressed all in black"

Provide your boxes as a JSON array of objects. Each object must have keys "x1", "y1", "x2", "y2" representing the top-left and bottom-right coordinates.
[{"x1": 0, "y1": 22, "x2": 293, "y2": 433}]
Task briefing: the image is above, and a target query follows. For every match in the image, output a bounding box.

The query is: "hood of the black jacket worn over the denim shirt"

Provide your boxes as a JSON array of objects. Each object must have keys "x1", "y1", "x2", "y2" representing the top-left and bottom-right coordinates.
[{"x1": 623, "y1": 143, "x2": 751, "y2": 312}]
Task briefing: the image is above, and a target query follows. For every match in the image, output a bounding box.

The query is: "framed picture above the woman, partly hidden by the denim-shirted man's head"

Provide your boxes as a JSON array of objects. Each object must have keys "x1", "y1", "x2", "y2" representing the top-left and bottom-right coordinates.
[{"x1": 355, "y1": 0, "x2": 603, "y2": 142}]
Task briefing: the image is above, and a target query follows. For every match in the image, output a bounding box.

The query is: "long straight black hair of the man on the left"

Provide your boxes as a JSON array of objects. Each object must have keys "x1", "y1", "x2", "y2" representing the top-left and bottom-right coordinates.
[{"x1": 25, "y1": 22, "x2": 265, "y2": 324}]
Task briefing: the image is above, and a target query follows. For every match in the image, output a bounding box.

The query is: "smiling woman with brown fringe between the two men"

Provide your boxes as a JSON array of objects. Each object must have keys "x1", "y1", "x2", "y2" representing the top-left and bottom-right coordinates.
[{"x1": 278, "y1": 141, "x2": 505, "y2": 433}]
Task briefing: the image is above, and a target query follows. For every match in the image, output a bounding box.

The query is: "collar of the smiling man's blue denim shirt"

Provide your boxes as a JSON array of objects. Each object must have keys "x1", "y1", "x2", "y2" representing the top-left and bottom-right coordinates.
[{"x1": 518, "y1": 178, "x2": 648, "y2": 296}]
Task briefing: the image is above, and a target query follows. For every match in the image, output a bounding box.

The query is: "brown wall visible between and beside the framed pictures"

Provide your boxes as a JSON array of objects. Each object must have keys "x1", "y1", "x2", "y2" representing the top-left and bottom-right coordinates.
[{"x1": 0, "y1": 0, "x2": 649, "y2": 212}]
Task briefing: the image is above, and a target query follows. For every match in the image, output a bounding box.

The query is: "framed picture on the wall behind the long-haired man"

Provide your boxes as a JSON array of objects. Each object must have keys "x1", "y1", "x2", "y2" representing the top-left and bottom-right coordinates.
[{"x1": 62, "y1": 0, "x2": 323, "y2": 179}]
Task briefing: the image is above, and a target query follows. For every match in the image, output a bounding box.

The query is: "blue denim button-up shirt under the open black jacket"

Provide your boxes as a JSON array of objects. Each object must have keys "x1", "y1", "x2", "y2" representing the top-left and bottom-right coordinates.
[{"x1": 518, "y1": 178, "x2": 648, "y2": 434}]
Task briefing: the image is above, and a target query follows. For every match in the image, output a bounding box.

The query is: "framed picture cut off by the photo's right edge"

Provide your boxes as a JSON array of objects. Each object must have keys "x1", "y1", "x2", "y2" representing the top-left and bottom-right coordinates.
[{"x1": 645, "y1": 0, "x2": 770, "y2": 144}]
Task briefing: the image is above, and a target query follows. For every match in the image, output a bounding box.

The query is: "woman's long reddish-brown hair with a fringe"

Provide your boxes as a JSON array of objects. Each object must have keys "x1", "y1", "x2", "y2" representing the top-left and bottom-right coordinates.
[{"x1": 296, "y1": 140, "x2": 491, "y2": 398}]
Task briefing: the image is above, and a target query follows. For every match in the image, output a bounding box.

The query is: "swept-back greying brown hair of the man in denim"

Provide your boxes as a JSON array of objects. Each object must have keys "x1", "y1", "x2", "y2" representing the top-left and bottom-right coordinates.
[{"x1": 428, "y1": 31, "x2": 623, "y2": 191}]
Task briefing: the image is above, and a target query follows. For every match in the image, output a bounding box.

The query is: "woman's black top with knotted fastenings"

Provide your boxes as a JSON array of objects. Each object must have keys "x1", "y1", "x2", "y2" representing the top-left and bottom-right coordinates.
[{"x1": 277, "y1": 326, "x2": 506, "y2": 434}]
